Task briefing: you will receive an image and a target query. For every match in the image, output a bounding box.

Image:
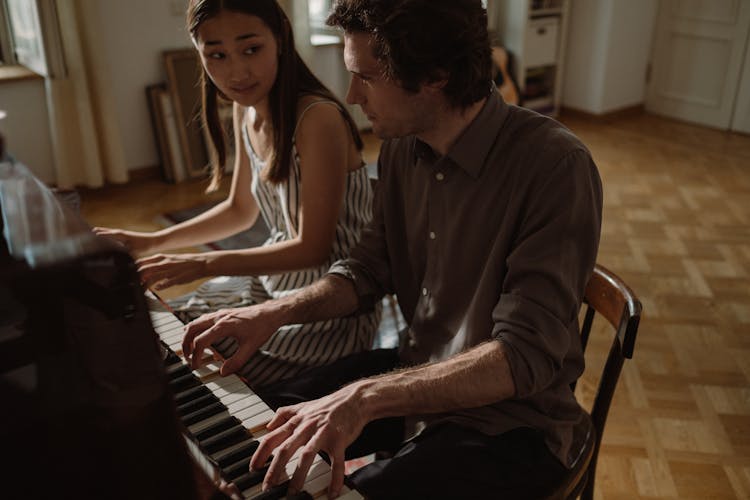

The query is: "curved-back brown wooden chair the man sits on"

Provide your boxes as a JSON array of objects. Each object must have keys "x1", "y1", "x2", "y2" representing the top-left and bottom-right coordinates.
[{"x1": 550, "y1": 264, "x2": 642, "y2": 500}]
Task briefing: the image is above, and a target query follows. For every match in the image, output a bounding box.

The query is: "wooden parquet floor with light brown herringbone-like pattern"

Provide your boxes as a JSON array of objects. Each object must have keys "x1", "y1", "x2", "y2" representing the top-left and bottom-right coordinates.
[{"x1": 82, "y1": 114, "x2": 750, "y2": 500}]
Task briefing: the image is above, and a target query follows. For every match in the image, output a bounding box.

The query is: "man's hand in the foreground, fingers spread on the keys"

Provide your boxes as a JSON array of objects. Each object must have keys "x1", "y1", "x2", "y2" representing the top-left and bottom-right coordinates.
[{"x1": 250, "y1": 383, "x2": 369, "y2": 498}]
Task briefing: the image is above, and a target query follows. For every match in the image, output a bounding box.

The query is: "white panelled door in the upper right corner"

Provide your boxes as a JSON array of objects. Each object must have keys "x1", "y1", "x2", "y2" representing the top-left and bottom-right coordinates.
[{"x1": 646, "y1": 0, "x2": 750, "y2": 129}]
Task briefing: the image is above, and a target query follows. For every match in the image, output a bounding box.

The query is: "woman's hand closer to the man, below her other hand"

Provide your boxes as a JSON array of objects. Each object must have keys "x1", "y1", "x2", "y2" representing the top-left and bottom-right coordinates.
[{"x1": 136, "y1": 253, "x2": 210, "y2": 290}]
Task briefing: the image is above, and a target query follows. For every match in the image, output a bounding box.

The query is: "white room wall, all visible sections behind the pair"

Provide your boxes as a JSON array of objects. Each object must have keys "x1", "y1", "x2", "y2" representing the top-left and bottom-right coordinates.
[{"x1": 0, "y1": 0, "x2": 668, "y2": 181}]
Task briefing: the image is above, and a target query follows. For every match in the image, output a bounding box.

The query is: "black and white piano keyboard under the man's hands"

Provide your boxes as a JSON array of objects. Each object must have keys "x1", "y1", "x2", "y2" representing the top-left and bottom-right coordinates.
[{"x1": 146, "y1": 293, "x2": 363, "y2": 500}]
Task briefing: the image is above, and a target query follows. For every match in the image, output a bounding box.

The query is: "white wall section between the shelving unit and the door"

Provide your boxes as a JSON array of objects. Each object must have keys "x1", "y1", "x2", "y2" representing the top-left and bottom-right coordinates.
[{"x1": 562, "y1": 0, "x2": 658, "y2": 114}]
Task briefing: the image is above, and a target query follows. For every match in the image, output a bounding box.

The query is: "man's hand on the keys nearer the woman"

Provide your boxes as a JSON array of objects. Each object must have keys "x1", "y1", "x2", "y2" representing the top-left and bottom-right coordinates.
[{"x1": 182, "y1": 305, "x2": 283, "y2": 376}]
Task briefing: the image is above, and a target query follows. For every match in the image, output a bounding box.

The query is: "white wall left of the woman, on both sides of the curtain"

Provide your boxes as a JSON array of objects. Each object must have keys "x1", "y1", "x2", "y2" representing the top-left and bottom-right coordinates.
[{"x1": 0, "y1": 0, "x2": 190, "y2": 178}]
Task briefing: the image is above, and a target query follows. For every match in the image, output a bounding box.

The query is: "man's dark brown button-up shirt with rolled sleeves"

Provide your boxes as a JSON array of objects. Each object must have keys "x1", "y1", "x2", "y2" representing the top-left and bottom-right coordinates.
[{"x1": 330, "y1": 94, "x2": 602, "y2": 466}]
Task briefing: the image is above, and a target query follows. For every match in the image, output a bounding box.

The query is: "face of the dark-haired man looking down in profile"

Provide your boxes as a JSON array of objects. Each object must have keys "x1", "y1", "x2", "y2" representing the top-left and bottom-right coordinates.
[{"x1": 344, "y1": 33, "x2": 436, "y2": 139}]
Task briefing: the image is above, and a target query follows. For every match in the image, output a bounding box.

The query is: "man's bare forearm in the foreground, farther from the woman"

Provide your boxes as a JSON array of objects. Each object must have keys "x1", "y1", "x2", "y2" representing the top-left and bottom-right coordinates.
[{"x1": 350, "y1": 340, "x2": 515, "y2": 420}]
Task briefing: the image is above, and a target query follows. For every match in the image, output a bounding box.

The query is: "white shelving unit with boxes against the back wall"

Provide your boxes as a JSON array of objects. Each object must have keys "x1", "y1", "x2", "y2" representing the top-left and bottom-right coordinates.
[{"x1": 488, "y1": 0, "x2": 570, "y2": 116}]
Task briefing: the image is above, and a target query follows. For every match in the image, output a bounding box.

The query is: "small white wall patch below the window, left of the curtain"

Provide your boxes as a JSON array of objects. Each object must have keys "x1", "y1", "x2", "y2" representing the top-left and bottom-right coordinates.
[{"x1": 0, "y1": 79, "x2": 55, "y2": 182}]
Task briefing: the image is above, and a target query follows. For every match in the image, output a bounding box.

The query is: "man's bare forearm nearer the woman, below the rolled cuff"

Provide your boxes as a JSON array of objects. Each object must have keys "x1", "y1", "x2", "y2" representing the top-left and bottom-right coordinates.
[{"x1": 265, "y1": 274, "x2": 359, "y2": 325}]
